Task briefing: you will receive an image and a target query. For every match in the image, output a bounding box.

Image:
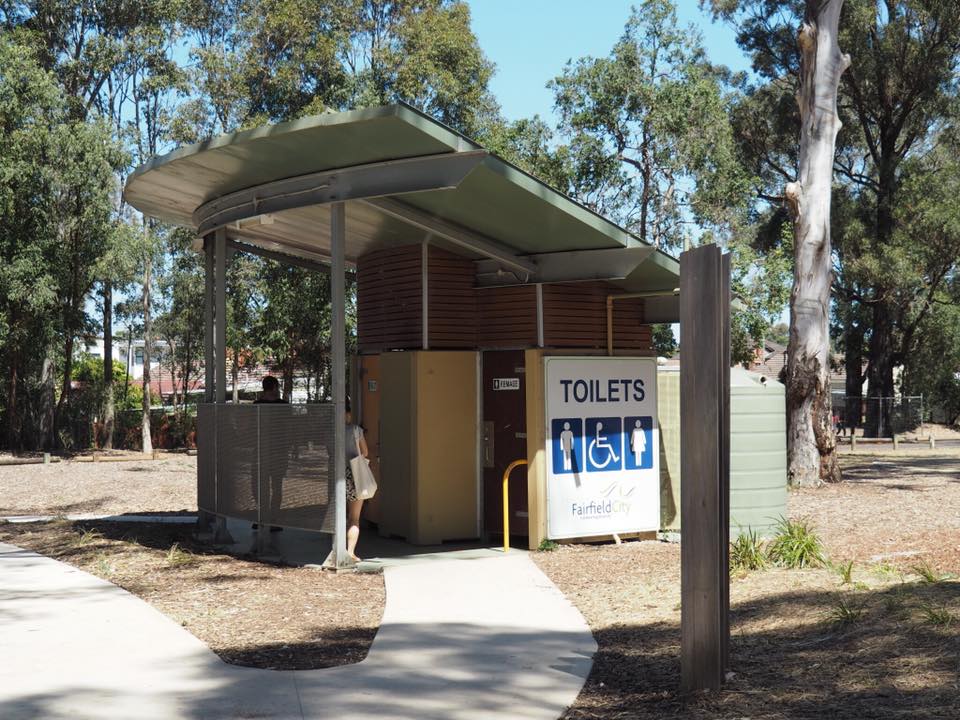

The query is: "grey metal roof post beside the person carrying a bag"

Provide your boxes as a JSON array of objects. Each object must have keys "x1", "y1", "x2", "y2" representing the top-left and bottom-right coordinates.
[{"x1": 330, "y1": 202, "x2": 349, "y2": 568}]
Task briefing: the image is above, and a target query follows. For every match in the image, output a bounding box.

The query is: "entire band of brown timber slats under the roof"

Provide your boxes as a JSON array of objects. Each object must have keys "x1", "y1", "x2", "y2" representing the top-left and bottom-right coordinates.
[{"x1": 357, "y1": 245, "x2": 652, "y2": 354}]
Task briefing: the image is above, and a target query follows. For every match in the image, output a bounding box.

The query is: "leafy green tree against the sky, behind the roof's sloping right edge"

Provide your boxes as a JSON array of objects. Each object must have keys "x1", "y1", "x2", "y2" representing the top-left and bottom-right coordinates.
[{"x1": 524, "y1": 0, "x2": 772, "y2": 361}]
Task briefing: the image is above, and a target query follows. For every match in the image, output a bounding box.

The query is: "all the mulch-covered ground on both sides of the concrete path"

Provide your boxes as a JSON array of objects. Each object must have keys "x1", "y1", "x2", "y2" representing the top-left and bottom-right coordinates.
[{"x1": 0, "y1": 452, "x2": 960, "y2": 720}]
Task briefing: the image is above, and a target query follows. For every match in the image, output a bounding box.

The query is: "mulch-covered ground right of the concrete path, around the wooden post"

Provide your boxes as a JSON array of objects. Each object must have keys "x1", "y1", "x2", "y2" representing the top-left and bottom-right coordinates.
[{"x1": 534, "y1": 455, "x2": 960, "y2": 720}]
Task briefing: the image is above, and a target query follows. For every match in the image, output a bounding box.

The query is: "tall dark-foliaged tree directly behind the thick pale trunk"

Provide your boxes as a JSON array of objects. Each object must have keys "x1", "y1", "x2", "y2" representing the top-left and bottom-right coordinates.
[{"x1": 711, "y1": 0, "x2": 960, "y2": 450}]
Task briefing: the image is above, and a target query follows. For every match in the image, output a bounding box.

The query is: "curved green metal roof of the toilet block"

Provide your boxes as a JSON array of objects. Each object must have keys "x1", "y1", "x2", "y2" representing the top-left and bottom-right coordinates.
[{"x1": 124, "y1": 105, "x2": 678, "y2": 290}]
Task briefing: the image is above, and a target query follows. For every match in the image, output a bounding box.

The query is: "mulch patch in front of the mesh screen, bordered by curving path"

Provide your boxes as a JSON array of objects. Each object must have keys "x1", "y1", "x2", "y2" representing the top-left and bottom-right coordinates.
[{"x1": 0, "y1": 521, "x2": 384, "y2": 669}]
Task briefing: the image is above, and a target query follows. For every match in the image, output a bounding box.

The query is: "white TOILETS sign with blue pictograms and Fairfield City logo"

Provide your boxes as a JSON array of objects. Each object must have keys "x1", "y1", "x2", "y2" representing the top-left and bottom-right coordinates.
[{"x1": 544, "y1": 357, "x2": 660, "y2": 538}]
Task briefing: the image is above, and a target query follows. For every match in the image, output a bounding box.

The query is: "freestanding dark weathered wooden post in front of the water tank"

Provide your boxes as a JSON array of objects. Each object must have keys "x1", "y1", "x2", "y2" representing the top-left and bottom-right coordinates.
[{"x1": 680, "y1": 245, "x2": 730, "y2": 692}]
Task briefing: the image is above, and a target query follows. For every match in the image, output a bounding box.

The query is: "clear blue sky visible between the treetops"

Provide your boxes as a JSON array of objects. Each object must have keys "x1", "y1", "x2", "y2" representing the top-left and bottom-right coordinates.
[{"x1": 470, "y1": 0, "x2": 749, "y2": 120}]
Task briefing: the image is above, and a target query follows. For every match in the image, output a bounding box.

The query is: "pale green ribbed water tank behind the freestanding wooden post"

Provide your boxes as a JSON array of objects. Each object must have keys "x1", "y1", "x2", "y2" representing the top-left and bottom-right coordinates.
[{"x1": 657, "y1": 368, "x2": 787, "y2": 538}]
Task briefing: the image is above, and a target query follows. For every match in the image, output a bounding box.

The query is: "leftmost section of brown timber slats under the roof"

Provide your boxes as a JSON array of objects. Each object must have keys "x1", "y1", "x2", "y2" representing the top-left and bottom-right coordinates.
[{"x1": 357, "y1": 245, "x2": 423, "y2": 352}]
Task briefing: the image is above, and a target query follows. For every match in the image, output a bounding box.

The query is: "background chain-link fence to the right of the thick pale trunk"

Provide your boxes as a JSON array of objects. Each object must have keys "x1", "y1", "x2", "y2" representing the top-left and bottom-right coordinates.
[{"x1": 831, "y1": 393, "x2": 924, "y2": 437}]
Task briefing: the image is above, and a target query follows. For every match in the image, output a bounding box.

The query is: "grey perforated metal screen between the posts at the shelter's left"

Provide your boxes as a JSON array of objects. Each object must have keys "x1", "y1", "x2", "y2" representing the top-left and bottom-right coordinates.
[{"x1": 197, "y1": 404, "x2": 335, "y2": 533}]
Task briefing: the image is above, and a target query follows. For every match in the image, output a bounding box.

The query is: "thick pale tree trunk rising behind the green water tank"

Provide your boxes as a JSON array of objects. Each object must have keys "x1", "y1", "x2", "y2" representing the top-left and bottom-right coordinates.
[{"x1": 784, "y1": 0, "x2": 850, "y2": 486}]
